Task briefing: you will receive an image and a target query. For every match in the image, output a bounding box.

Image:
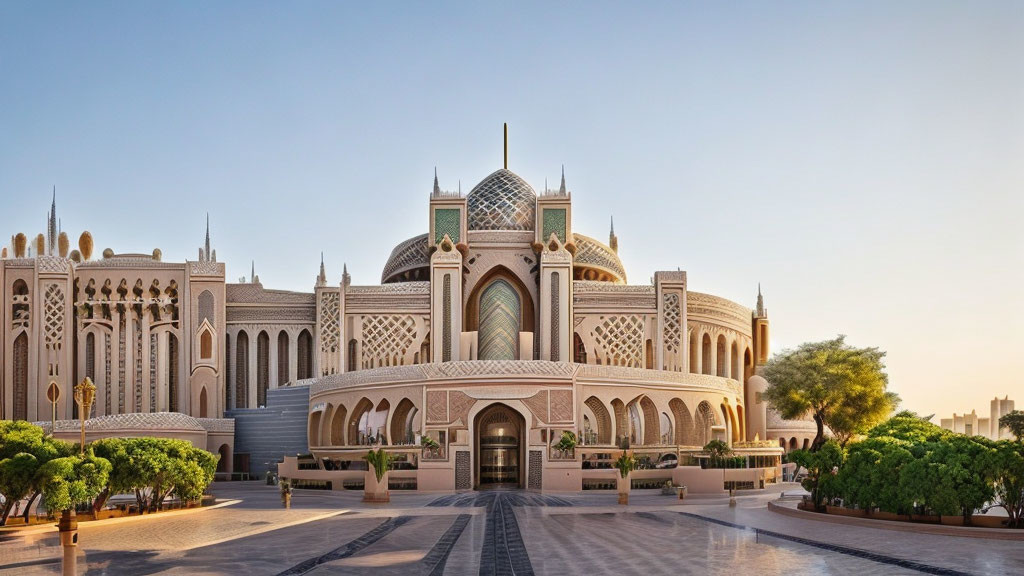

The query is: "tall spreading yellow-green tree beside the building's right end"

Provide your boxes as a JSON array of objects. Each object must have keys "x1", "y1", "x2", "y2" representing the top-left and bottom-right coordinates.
[{"x1": 764, "y1": 336, "x2": 899, "y2": 452}]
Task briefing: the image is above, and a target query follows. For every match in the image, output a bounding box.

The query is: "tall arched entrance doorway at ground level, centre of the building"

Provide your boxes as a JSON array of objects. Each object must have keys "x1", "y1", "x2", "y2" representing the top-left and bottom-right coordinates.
[{"x1": 473, "y1": 404, "x2": 525, "y2": 489}]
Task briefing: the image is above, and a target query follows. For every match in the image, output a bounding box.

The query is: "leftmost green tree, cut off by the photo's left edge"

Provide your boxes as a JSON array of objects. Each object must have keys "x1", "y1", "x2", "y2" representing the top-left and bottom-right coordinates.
[{"x1": 0, "y1": 420, "x2": 73, "y2": 526}]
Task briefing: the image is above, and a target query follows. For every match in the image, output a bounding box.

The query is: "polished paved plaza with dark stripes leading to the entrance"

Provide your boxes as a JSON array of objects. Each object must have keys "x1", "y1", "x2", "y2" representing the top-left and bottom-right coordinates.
[{"x1": 0, "y1": 483, "x2": 1024, "y2": 576}]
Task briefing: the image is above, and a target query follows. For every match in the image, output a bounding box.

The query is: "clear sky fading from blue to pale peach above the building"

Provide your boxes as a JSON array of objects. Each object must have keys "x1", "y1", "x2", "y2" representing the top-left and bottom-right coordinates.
[{"x1": 0, "y1": 1, "x2": 1024, "y2": 416}]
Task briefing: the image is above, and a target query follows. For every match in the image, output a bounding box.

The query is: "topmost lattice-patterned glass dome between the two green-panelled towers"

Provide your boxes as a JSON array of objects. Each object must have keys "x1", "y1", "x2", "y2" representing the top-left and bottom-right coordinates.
[{"x1": 466, "y1": 169, "x2": 537, "y2": 230}]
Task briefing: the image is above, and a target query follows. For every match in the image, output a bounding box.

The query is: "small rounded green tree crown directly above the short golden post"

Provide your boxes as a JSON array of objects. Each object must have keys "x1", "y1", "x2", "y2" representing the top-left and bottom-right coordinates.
[{"x1": 39, "y1": 450, "x2": 111, "y2": 511}]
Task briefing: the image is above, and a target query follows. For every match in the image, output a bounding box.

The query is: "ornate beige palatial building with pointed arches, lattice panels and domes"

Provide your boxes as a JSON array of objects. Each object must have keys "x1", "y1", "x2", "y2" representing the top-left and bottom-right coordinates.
[{"x1": 0, "y1": 136, "x2": 784, "y2": 490}]
